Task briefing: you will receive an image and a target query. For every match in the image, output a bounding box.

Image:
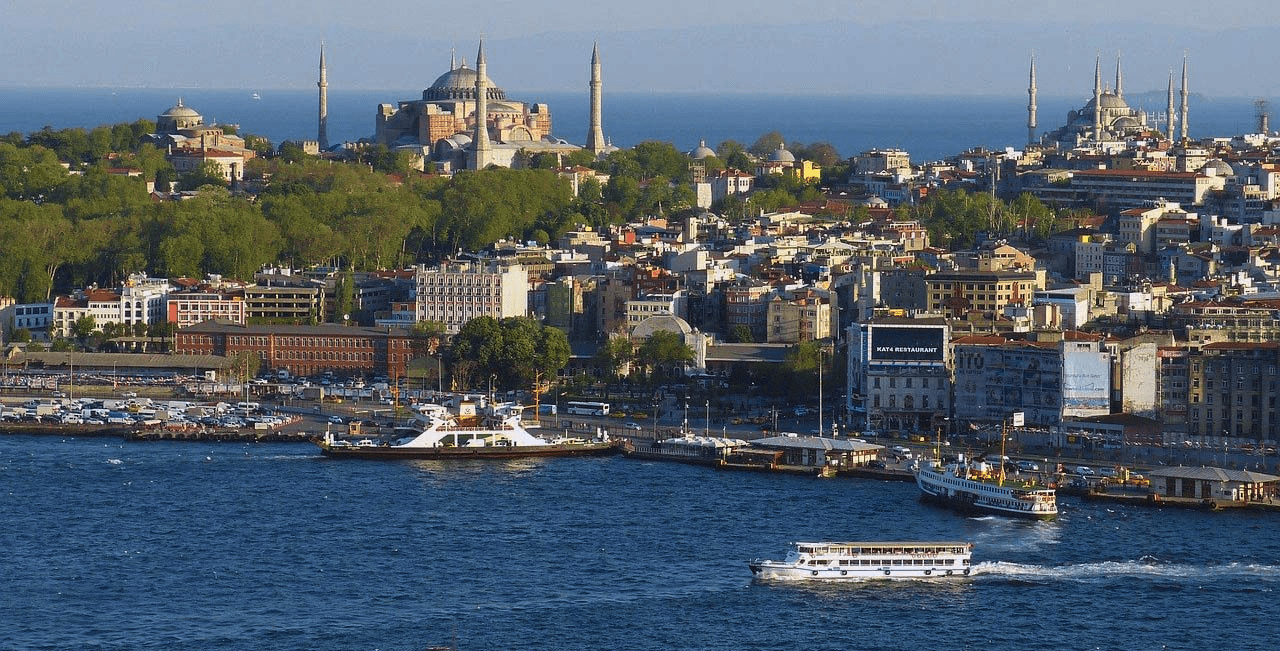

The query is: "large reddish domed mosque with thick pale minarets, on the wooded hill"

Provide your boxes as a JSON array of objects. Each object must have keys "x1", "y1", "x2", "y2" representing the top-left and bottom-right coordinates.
[{"x1": 374, "y1": 41, "x2": 608, "y2": 173}]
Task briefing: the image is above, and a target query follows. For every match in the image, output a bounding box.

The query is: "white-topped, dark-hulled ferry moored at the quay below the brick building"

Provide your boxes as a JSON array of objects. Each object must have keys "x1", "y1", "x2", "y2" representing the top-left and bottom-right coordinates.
[{"x1": 314, "y1": 405, "x2": 622, "y2": 459}]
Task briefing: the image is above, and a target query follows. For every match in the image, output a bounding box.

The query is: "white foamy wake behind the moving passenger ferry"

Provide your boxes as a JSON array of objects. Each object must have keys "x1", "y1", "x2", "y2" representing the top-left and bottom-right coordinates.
[{"x1": 973, "y1": 556, "x2": 1280, "y2": 583}]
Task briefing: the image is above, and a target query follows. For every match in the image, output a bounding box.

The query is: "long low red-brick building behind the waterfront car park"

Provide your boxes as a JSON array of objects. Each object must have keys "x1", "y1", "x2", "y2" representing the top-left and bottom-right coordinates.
[{"x1": 174, "y1": 321, "x2": 413, "y2": 377}]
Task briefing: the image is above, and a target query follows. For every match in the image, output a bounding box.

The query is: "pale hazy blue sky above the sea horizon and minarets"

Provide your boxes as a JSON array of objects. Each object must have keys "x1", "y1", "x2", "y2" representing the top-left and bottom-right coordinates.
[{"x1": 0, "y1": 0, "x2": 1280, "y2": 97}]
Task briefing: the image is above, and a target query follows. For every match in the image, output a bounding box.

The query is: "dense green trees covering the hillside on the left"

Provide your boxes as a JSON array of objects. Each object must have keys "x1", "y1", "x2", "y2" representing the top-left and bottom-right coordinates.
[{"x1": 0, "y1": 120, "x2": 586, "y2": 302}]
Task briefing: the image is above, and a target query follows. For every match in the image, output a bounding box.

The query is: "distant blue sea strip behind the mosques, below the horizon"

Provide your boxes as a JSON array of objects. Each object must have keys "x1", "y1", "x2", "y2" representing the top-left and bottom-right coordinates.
[{"x1": 0, "y1": 87, "x2": 1256, "y2": 161}]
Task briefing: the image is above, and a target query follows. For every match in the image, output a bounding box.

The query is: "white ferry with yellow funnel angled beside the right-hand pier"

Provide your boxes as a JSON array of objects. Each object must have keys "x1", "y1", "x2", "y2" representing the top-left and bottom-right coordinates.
[{"x1": 915, "y1": 458, "x2": 1057, "y2": 519}]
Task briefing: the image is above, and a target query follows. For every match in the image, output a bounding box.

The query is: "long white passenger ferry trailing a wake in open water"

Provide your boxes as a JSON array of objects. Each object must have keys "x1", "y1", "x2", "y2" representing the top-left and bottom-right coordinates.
[{"x1": 749, "y1": 542, "x2": 973, "y2": 581}]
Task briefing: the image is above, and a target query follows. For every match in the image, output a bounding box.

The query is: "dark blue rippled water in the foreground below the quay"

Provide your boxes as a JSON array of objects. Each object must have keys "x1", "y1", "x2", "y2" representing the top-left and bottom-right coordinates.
[{"x1": 0, "y1": 436, "x2": 1280, "y2": 651}]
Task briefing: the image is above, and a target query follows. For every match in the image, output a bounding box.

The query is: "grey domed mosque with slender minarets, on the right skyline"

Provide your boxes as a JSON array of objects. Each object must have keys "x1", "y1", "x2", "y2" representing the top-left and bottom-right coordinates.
[{"x1": 1027, "y1": 56, "x2": 1187, "y2": 148}]
